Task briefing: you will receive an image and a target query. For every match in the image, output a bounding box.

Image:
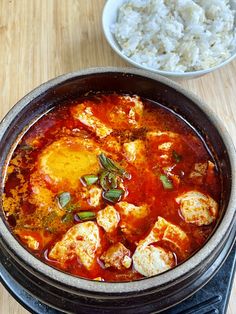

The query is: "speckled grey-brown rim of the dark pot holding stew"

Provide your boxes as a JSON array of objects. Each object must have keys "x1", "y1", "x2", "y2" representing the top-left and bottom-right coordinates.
[{"x1": 0, "y1": 67, "x2": 236, "y2": 296}]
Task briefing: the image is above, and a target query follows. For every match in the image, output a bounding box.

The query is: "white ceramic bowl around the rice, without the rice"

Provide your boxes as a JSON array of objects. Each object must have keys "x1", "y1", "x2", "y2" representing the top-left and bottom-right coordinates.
[{"x1": 102, "y1": 0, "x2": 236, "y2": 79}]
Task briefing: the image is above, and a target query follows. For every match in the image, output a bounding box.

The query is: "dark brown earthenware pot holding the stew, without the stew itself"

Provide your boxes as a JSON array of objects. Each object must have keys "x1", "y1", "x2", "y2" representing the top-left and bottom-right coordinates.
[{"x1": 0, "y1": 68, "x2": 236, "y2": 313}]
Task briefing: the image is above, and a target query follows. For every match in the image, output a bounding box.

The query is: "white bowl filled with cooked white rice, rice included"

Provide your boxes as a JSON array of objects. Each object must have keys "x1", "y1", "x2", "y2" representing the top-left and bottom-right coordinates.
[{"x1": 102, "y1": 0, "x2": 236, "y2": 78}]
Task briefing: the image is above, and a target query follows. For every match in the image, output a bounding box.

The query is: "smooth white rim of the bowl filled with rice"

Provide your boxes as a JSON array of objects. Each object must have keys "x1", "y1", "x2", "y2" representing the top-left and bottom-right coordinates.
[{"x1": 102, "y1": 0, "x2": 236, "y2": 79}]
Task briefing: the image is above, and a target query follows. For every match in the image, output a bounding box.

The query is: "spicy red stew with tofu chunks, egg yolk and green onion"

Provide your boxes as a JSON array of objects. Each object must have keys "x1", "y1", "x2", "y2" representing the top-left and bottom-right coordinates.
[{"x1": 3, "y1": 94, "x2": 220, "y2": 281}]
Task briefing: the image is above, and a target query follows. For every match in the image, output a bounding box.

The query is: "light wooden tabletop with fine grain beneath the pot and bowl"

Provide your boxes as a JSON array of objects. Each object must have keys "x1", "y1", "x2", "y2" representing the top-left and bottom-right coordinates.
[{"x1": 0, "y1": 0, "x2": 236, "y2": 314}]
